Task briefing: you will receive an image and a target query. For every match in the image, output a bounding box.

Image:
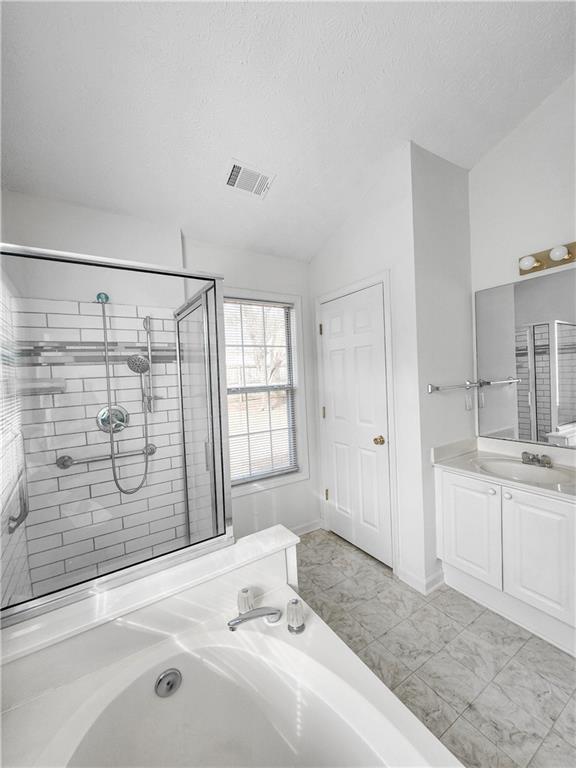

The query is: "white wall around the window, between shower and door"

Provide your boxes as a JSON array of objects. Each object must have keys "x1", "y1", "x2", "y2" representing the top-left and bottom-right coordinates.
[{"x1": 183, "y1": 233, "x2": 320, "y2": 536}]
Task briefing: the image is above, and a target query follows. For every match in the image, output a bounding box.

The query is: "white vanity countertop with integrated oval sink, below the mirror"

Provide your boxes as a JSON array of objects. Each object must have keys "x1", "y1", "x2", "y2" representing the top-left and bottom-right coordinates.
[{"x1": 434, "y1": 450, "x2": 576, "y2": 498}]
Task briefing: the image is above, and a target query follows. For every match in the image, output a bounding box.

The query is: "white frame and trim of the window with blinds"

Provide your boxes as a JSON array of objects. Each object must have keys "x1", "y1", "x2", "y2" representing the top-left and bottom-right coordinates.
[{"x1": 224, "y1": 287, "x2": 310, "y2": 498}]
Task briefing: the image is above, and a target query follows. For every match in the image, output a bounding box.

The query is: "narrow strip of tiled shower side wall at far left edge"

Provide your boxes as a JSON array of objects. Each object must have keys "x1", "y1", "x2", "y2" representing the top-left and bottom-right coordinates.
[{"x1": 0, "y1": 279, "x2": 32, "y2": 605}]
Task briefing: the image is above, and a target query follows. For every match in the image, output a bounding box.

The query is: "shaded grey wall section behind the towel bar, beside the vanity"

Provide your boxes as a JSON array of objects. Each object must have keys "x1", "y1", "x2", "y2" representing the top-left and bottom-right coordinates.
[{"x1": 411, "y1": 144, "x2": 475, "y2": 579}]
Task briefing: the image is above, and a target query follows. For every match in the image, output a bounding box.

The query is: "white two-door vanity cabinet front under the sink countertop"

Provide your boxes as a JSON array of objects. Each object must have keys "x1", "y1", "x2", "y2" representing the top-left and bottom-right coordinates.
[{"x1": 435, "y1": 466, "x2": 576, "y2": 650}]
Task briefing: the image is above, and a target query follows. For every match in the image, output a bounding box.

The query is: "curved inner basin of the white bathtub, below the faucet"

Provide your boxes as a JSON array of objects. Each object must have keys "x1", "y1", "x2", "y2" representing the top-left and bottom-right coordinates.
[{"x1": 60, "y1": 636, "x2": 384, "y2": 768}]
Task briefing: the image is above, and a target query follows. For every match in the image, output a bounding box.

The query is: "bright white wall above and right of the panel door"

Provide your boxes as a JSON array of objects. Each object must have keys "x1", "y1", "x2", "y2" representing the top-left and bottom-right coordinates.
[{"x1": 310, "y1": 143, "x2": 425, "y2": 582}]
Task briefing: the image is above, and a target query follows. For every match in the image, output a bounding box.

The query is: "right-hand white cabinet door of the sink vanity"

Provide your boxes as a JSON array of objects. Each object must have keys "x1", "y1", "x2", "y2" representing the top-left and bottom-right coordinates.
[{"x1": 502, "y1": 488, "x2": 576, "y2": 624}]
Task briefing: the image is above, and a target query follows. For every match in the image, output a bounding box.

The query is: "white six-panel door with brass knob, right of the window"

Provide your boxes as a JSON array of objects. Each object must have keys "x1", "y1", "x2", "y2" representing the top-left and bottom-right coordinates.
[{"x1": 320, "y1": 285, "x2": 392, "y2": 565}]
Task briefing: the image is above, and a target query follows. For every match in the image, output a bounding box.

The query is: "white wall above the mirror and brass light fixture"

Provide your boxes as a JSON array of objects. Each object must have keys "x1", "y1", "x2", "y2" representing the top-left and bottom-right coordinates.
[{"x1": 470, "y1": 78, "x2": 576, "y2": 291}]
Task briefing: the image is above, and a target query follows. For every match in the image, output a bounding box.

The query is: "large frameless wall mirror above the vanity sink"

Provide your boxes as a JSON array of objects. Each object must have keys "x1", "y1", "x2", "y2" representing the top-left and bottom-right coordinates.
[{"x1": 476, "y1": 269, "x2": 576, "y2": 448}]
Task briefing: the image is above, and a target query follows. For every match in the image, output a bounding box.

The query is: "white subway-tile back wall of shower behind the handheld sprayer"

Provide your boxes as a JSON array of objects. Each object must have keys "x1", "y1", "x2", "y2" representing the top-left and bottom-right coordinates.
[{"x1": 13, "y1": 299, "x2": 210, "y2": 595}]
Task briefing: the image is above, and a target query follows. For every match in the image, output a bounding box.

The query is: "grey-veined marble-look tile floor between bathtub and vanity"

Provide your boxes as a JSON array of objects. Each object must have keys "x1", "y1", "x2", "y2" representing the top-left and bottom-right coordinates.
[{"x1": 298, "y1": 530, "x2": 576, "y2": 768}]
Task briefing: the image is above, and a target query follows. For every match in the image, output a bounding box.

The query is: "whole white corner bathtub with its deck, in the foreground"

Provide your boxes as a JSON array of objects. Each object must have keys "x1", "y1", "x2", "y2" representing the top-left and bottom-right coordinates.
[{"x1": 2, "y1": 528, "x2": 460, "y2": 768}]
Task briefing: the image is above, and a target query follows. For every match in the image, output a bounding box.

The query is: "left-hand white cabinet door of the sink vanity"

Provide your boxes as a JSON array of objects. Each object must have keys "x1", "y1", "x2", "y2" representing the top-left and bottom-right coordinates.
[{"x1": 442, "y1": 472, "x2": 502, "y2": 589}]
